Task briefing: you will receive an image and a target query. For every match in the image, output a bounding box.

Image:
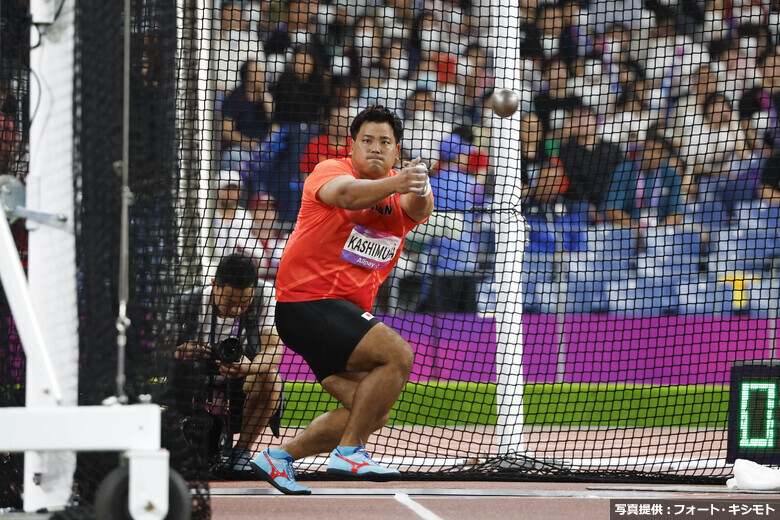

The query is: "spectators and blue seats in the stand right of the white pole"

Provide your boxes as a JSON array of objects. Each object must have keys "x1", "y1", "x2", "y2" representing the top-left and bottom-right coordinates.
[{"x1": 520, "y1": 0, "x2": 780, "y2": 312}]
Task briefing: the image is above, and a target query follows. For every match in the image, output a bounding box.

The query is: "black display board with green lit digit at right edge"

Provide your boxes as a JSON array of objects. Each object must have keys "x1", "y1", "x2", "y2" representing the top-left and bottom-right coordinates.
[{"x1": 726, "y1": 360, "x2": 780, "y2": 465}]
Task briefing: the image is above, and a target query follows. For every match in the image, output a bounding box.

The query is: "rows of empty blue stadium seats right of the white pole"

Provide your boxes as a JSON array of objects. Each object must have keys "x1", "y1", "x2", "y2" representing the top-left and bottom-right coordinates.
[{"x1": 522, "y1": 209, "x2": 780, "y2": 317}]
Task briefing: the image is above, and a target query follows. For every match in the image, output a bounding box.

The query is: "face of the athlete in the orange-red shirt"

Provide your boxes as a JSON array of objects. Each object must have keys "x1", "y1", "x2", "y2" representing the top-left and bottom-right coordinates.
[{"x1": 350, "y1": 121, "x2": 401, "y2": 179}]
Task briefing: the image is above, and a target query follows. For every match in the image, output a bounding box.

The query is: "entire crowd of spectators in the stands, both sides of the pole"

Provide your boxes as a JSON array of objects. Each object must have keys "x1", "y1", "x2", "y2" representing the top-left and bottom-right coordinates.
[{"x1": 209, "y1": 0, "x2": 780, "y2": 316}]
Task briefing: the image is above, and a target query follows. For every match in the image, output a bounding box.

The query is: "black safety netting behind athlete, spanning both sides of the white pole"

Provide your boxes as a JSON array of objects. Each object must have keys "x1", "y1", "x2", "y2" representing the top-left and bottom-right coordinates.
[{"x1": 184, "y1": 1, "x2": 777, "y2": 481}]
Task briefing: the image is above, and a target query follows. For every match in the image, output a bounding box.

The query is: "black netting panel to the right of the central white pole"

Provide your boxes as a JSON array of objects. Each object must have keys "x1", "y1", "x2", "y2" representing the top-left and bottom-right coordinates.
[{"x1": 520, "y1": 2, "x2": 778, "y2": 479}]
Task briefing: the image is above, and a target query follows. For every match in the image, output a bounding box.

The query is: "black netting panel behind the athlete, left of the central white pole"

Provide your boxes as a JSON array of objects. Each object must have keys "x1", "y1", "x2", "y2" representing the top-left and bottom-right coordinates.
[{"x1": 184, "y1": 1, "x2": 520, "y2": 486}]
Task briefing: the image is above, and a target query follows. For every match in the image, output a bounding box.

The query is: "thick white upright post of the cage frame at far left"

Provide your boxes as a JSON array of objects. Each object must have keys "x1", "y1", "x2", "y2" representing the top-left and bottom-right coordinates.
[{"x1": 24, "y1": 0, "x2": 78, "y2": 511}]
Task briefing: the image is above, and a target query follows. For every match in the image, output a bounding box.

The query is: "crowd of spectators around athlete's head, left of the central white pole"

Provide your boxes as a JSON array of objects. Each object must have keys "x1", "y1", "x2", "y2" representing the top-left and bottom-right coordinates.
[{"x1": 214, "y1": 0, "x2": 494, "y2": 312}]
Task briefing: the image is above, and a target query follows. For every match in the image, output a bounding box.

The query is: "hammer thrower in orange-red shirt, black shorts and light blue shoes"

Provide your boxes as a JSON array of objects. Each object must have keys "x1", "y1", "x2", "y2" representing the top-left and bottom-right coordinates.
[{"x1": 250, "y1": 105, "x2": 433, "y2": 495}]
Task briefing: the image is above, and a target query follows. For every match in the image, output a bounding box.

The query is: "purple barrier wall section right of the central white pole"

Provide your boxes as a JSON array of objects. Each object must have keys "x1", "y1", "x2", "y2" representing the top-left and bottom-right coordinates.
[{"x1": 523, "y1": 315, "x2": 772, "y2": 385}]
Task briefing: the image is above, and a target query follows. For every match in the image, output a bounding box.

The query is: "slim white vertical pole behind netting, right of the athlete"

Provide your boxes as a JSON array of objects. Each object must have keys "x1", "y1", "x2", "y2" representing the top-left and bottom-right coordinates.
[{"x1": 486, "y1": 0, "x2": 525, "y2": 454}]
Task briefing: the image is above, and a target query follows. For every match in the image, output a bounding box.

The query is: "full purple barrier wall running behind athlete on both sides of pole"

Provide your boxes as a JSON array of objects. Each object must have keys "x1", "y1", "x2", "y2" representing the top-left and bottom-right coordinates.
[{"x1": 282, "y1": 314, "x2": 772, "y2": 385}]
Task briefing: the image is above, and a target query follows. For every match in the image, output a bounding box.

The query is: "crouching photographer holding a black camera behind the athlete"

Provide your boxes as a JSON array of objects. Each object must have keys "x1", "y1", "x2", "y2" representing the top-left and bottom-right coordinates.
[{"x1": 168, "y1": 253, "x2": 284, "y2": 472}]
